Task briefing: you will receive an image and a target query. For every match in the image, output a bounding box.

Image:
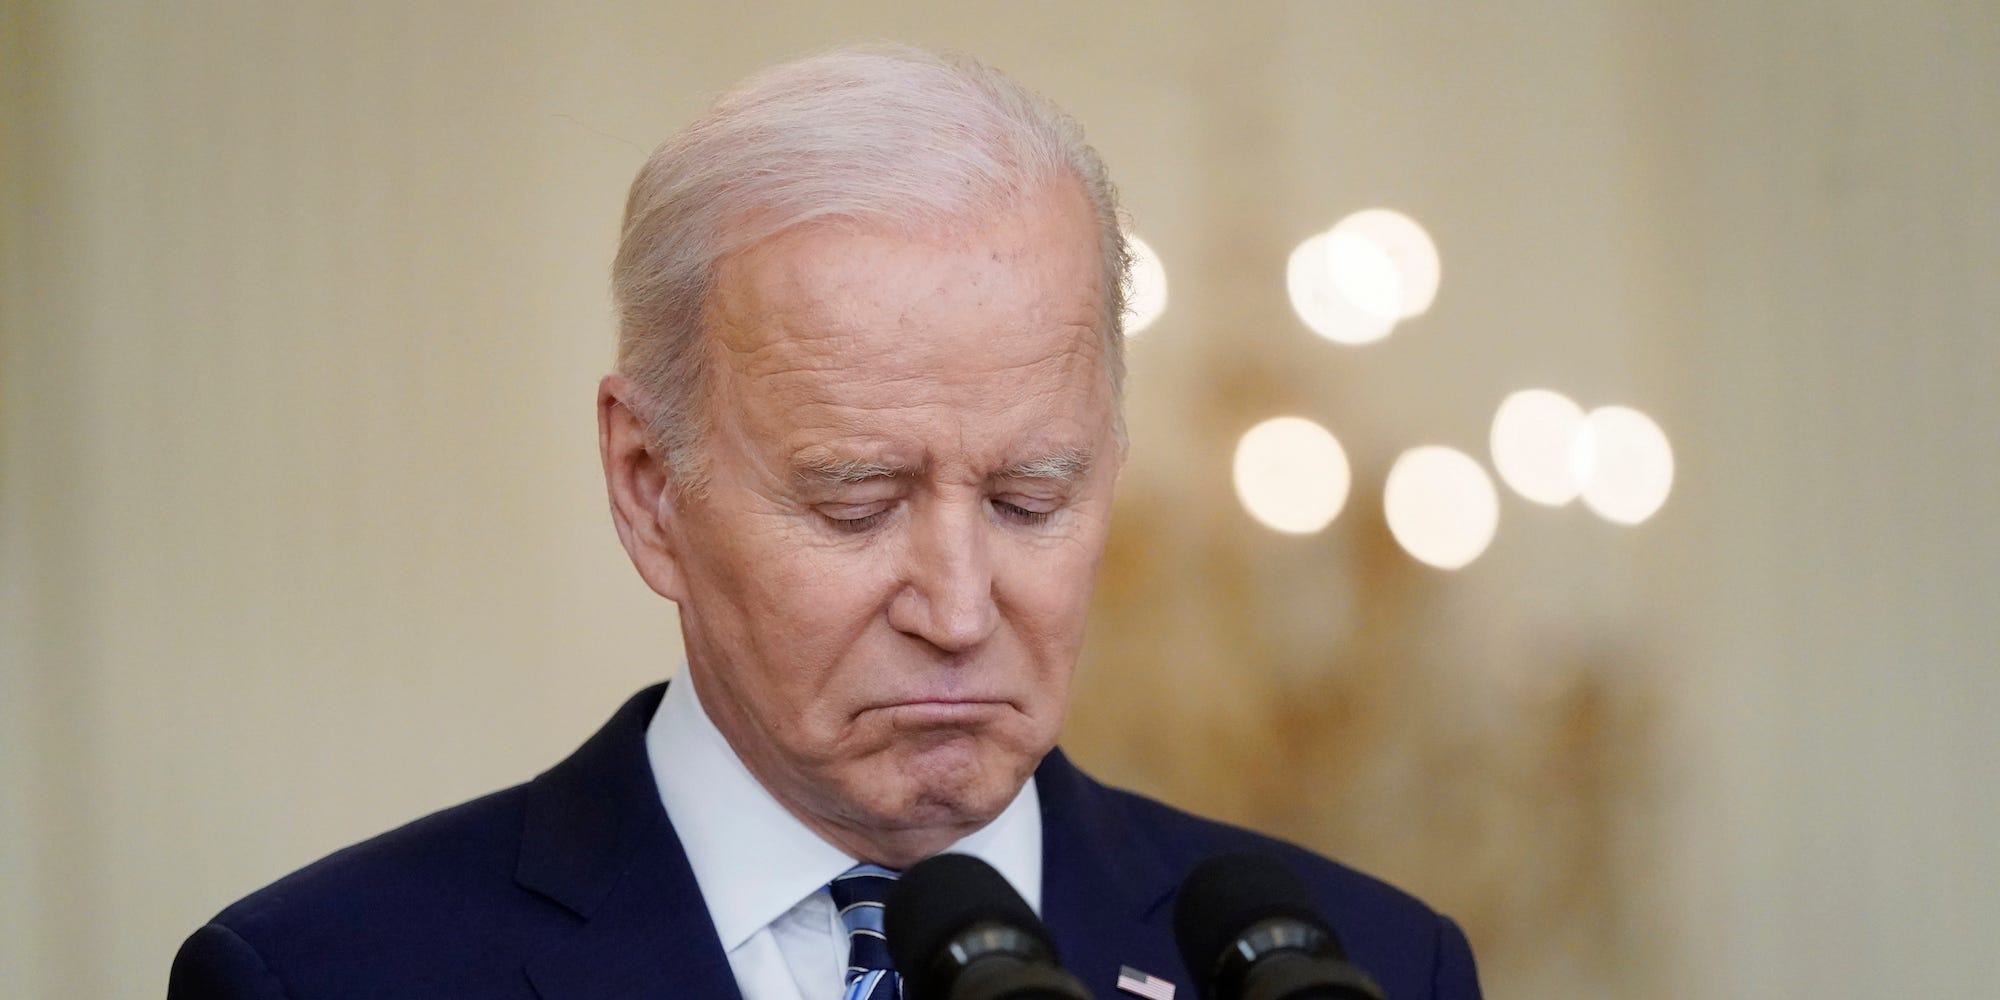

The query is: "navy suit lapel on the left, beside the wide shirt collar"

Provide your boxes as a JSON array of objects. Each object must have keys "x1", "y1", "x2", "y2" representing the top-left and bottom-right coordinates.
[{"x1": 514, "y1": 684, "x2": 738, "y2": 1000}]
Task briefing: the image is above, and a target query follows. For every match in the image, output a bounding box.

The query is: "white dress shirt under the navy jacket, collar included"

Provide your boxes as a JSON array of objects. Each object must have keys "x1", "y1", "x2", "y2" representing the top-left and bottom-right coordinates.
[{"x1": 646, "y1": 670, "x2": 1042, "y2": 1000}]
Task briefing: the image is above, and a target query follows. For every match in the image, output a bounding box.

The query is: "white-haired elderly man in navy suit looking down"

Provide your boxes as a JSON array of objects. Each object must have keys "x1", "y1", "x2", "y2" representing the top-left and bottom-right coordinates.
[{"x1": 170, "y1": 48, "x2": 1478, "y2": 1000}]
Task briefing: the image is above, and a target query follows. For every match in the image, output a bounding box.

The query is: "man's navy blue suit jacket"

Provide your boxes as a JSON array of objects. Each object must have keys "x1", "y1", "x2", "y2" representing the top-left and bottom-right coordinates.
[{"x1": 168, "y1": 684, "x2": 1478, "y2": 1000}]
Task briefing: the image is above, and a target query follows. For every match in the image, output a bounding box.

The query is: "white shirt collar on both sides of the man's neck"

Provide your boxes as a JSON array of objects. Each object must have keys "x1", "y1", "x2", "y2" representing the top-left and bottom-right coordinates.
[{"x1": 646, "y1": 668, "x2": 1042, "y2": 950}]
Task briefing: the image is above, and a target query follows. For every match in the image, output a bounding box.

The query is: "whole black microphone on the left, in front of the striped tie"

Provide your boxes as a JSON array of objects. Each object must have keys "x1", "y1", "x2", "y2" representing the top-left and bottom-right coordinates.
[{"x1": 882, "y1": 854, "x2": 1090, "y2": 1000}]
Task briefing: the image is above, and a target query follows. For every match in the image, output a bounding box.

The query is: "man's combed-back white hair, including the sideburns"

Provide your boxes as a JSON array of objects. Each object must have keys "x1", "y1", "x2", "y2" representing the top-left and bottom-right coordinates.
[{"x1": 612, "y1": 46, "x2": 1130, "y2": 486}]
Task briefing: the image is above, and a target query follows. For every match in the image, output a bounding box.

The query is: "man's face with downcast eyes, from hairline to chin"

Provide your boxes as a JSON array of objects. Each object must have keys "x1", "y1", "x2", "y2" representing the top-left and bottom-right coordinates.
[{"x1": 666, "y1": 184, "x2": 1122, "y2": 860}]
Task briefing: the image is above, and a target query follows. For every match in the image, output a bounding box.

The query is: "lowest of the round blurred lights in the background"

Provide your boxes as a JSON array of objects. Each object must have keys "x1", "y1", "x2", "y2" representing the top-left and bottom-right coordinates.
[{"x1": 1382, "y1": 444, "x2": 1500, "y2": 570}]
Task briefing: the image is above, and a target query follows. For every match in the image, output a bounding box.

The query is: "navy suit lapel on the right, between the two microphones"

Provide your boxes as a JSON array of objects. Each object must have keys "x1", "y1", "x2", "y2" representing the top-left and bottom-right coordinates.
[{"x1": 1034, "y1": 750, "x2": 1192, "y2": 998}]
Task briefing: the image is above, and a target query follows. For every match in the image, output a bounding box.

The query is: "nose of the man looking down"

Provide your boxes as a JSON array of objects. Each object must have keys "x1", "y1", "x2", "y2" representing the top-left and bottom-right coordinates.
[{"x1": 888, "y1": 504, "x2": 1000, "y2": 652}]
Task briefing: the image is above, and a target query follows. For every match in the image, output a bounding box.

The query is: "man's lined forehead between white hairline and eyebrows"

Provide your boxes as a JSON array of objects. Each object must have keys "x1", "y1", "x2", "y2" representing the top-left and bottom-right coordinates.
[{"x1": 708, "y1": 190, "x2": 1112, "y2": 472}]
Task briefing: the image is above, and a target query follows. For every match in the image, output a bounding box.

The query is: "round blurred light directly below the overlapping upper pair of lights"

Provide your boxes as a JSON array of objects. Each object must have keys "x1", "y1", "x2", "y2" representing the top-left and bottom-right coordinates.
[{"x1": 1234, "y1": 416, "x2": 1350, "y2": 534}]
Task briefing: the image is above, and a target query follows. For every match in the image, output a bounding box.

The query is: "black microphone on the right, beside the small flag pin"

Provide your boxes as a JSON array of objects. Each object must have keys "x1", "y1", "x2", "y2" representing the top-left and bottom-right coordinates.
[{"x1": 1174, "y1": 854, "x2": 1382, "y2": 1000}]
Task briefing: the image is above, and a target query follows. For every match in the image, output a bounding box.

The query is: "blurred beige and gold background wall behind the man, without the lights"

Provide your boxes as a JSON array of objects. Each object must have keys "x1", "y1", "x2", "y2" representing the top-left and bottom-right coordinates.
[{"x1": 0, "y1": 0, "x2": 2000, "y2": 998}]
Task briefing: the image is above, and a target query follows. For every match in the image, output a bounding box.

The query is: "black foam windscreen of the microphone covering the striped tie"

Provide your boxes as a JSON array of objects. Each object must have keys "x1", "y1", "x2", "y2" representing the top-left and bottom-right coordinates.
[{"x1": 882, "y1": 854, "x2": 1054, "y2": 996}]
